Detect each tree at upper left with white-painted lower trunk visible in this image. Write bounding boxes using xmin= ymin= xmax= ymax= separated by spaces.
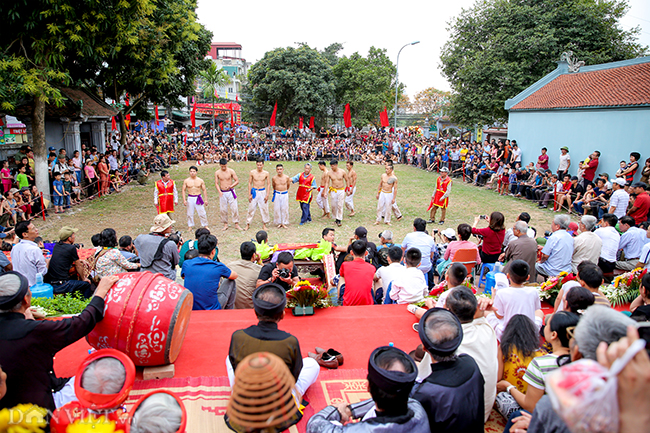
xmin=0 ymin=0 xmax=152 ymax=191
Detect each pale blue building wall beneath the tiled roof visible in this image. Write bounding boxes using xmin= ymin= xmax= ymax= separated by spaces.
xmin=508 ymin=107 xmax=650 ymax=180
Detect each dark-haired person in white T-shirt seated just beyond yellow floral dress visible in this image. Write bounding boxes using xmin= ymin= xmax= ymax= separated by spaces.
xmin=479 ymin=260 xmax=542 ymax=339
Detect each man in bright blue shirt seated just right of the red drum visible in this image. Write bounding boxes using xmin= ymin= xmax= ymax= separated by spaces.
xmin=181 ymin=235 xmax=237 ymax=310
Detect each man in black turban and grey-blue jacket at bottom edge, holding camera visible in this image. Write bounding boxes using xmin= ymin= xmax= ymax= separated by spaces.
xmin=307 ymin=346 xmax=431 ymax=433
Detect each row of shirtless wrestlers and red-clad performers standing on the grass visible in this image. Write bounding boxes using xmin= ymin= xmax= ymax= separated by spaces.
xmin=154 ymin=159 xmax=452 ymax=231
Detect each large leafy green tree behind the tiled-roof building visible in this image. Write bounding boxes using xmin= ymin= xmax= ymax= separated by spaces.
xmin=441 ymin=0 xmax=646 ymax=125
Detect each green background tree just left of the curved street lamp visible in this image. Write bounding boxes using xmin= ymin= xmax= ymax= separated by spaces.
xmin=333 ymin=47 xmax=403 ymax=127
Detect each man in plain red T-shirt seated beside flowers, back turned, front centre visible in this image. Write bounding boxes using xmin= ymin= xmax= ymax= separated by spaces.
xmin=339 ymin=240 xmax=376 ymax=306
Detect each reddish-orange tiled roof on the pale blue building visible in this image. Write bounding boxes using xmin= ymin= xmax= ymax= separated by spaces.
xmin=511 ymin=62 xmax=650 ymax=110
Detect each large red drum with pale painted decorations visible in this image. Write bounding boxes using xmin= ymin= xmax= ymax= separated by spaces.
xmin=86 ymin=272 xmax=194 ymax=367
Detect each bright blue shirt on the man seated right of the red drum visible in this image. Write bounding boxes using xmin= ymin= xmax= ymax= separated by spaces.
xmin=181 ymin=257 xmax=231 ymax=310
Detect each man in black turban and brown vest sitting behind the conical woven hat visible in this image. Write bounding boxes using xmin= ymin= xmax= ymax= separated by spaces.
xmin=226 ymin=283 xmax=320 ymax=396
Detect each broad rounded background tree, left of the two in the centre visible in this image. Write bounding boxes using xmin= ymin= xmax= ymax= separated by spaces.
xmin=244 ymin=44 xmax=334 ymax=125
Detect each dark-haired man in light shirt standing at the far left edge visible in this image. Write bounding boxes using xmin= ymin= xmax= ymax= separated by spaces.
xmin=11 ymin=221 xmax=47 ymax=287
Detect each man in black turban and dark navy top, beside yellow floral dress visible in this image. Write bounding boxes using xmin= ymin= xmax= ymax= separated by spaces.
xmin=411 ymin=308 xmax=484 ymax=433
